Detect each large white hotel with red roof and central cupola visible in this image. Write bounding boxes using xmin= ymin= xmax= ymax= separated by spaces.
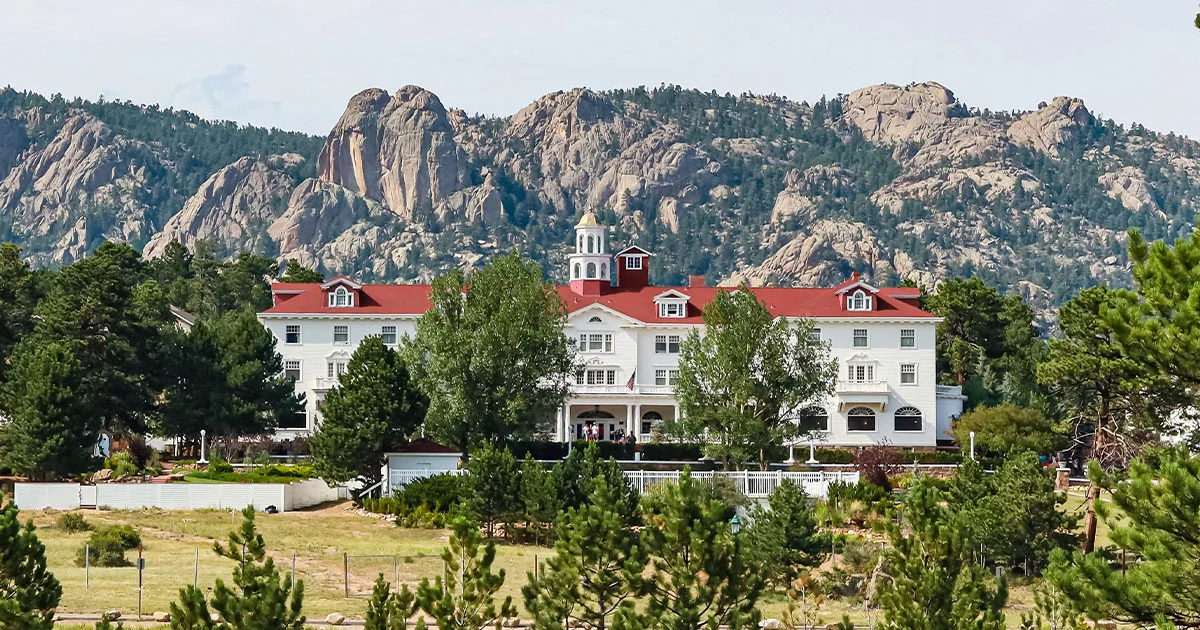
xmin=259 ymin=212 xmax=964 ymax=449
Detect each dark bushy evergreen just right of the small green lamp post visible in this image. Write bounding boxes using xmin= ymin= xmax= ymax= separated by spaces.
xmin=742 ymin=481 xmax=829 ymax=584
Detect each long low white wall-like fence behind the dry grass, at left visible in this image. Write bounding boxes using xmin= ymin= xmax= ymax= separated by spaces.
xmin=14 ymin=479 xmax=340 ymax=511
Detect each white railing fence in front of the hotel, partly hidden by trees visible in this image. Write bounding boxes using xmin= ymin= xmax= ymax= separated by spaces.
xmin=390 ymin=470 xmax=858 ymax=498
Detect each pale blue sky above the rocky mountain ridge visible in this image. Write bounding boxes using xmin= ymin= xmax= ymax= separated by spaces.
xmin=0 ymin=0 xmax=1200 ymax=137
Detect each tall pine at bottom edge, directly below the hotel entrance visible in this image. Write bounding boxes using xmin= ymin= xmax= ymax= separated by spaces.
xmin=521 ymin=478 xmax=647 ymax=630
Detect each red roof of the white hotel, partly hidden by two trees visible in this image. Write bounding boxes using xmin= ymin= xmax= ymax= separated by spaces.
xmin=264 ymin=283 xmax=935 ymax=324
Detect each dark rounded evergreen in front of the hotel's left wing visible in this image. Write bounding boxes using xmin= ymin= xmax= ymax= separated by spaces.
xmin=308 ymin=337 xmax=427 ymax=487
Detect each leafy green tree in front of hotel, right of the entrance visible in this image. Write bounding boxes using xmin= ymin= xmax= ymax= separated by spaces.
xmin=666 ymin=289 xmax=836 ymax=469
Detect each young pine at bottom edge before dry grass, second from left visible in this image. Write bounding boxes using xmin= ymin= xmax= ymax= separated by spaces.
xmin=170 ymin=508 xmax=305 ymax=630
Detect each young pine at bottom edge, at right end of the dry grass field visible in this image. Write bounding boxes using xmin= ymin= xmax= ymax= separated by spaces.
xmin=416 ymin=516 xmax=516 ymax=630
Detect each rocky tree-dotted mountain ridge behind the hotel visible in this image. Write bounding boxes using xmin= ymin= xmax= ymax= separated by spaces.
xmin=0 ymin=82 xmax=1200 ymax=319
